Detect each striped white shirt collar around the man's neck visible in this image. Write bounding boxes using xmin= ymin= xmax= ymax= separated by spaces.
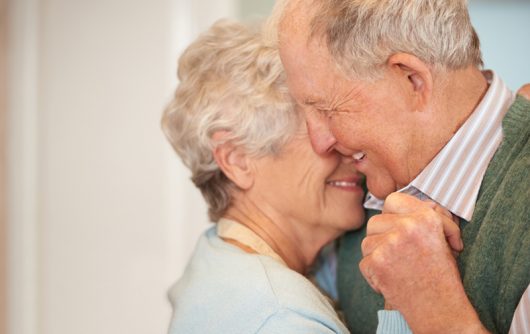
xmin=364 ymin=71 xmax=515 ymax=221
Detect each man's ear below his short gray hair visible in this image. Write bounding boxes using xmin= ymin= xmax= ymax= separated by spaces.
xmin=387 ymin=53 xmax=433 ymax=111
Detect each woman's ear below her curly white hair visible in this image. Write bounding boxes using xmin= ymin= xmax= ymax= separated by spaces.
xmin=212 ymin=131 xmax=254 ymax=190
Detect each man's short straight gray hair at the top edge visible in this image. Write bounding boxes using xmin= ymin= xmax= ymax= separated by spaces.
xmin=302 ymin=0 xmax=482 ymax=78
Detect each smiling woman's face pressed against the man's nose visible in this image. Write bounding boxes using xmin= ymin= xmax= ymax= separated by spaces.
xmin=254 ymin=124 xmax=364 ymax=236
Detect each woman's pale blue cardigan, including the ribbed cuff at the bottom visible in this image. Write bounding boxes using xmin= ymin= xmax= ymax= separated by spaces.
xmin=169 ymin=227 xmax=408 ymax=334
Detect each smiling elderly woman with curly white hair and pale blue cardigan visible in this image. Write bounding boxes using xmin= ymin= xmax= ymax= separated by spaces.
xmin=163 ymin=21 xmax=412 ymax=333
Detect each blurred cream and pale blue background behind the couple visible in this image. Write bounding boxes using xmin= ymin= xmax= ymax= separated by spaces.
xmin=0 ymin=0 xmax=530 ymax=334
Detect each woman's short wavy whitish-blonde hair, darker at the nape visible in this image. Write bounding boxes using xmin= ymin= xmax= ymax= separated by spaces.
xmin=162 ymin=20 xmax=300 ymax=221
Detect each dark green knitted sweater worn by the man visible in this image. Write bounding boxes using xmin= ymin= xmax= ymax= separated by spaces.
xmin=337 ymin=96 xmax=530 ymax=334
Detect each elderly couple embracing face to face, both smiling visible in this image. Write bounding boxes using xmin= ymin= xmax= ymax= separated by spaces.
xmin=162 ymin=0 xmax=530 ymax=333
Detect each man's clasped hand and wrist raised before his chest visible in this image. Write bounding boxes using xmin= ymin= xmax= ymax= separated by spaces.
xmin=359 ymin=193 xmax=485 ymax=333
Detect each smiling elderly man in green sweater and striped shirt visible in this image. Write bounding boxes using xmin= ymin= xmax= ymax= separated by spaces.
xmin=276 ymin=0 xmax=530 ymax=333
